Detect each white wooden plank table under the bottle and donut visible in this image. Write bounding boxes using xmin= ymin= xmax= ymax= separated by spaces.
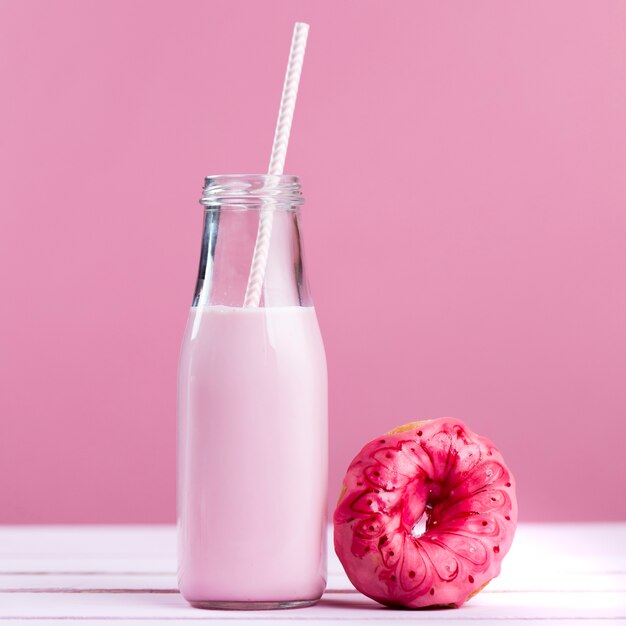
xmin=0 ymin=523 xmax=626 ymax=626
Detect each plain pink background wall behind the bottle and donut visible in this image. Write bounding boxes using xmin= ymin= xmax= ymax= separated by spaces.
xmin=0 ymin=0 xmax=626 ymax=522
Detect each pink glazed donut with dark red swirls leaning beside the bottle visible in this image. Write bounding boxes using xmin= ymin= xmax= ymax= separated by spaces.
xmin=334 ymin=418 xmax=517 ymax=608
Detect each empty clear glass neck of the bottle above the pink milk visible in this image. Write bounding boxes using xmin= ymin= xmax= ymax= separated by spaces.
xmin=193 ymin=175 xmax=312 ymax=307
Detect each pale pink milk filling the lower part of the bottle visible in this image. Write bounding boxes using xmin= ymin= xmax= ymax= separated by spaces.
xmin=178 ymin=305 xmax=328 ymax=608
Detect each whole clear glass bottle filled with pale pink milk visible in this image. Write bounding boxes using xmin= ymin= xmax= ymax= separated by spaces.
xmin=178 ymin=175 xmax=328 ymax=609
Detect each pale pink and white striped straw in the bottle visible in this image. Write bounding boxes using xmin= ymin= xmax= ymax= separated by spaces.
xmin=243 ymin=22 xmax=309 ymax=307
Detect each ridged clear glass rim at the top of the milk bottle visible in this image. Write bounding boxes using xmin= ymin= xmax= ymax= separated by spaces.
xmin=200 ymin=174 xmax=304 ymax=208
